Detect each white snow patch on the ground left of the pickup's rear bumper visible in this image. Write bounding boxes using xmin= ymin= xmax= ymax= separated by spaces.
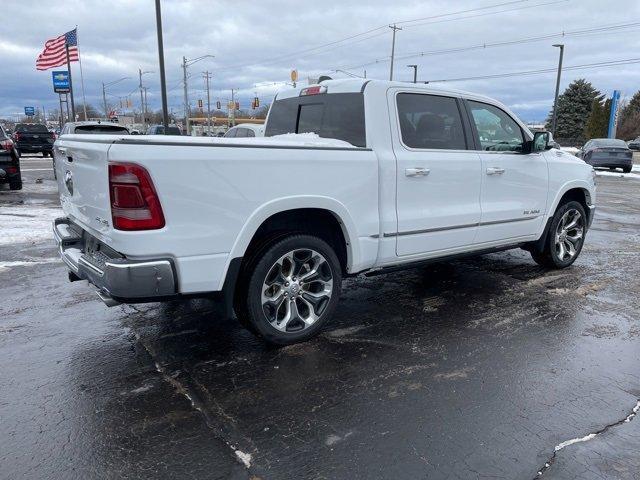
xmin=0 ymin=205 xmax=63 ymax=245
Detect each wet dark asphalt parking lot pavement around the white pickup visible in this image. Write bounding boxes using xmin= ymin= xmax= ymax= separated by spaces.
xmin=0 ymin=160 xmax=640 ymax=479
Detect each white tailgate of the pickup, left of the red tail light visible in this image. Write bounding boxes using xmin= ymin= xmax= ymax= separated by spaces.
xmin=53 ymin=135 xmax=113 ymax=237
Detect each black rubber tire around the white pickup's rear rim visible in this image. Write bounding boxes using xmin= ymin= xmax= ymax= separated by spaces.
xmin=236 ymin=234 xmax=342 ymax=345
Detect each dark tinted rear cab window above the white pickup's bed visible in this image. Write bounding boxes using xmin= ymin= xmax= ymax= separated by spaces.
xmin=264 ymin=93 xmax=367 ymax=147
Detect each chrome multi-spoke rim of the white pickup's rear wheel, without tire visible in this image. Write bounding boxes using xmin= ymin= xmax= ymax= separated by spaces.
xmin=262 ymin=248 xmax=333 ymax=332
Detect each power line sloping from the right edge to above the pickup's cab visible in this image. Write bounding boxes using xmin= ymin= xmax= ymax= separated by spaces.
xmin=340 ymin=22 xmax=640 ymax=70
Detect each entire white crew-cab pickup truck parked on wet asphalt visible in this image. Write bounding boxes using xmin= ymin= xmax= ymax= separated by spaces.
xmin=54 ymin=79 xmax=595 ymax=344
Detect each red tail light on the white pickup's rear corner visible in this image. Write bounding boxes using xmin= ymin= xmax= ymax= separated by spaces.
xmin=109 ymin=163 xmax=164 ymax=230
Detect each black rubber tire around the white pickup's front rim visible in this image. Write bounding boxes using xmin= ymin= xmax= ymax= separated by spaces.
xmin=531 ymin=200 xmax=588 ymax=269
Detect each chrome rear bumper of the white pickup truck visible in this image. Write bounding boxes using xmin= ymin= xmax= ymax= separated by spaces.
xmin=53 ymin=217 xmax=177 ymax=306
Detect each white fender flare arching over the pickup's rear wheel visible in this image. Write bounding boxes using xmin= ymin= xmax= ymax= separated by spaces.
xmin=220 ymin=195 xmax=361 ymax=288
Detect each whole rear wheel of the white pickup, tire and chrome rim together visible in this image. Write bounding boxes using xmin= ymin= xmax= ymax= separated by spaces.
xmin=238 ymin=235 xmax=342 ymax=345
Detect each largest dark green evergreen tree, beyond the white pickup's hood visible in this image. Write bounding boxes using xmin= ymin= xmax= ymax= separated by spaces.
xmin=546 ymin=78 xmax=600 ymax=142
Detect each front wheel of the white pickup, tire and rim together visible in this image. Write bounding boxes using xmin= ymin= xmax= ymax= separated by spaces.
xmin=531 ymin=201 xmax=587 ymax=268
